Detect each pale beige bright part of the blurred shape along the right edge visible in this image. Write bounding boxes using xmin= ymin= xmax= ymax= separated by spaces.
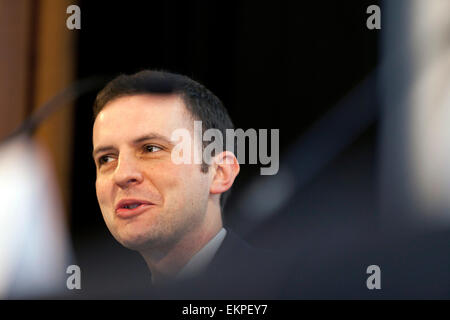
xmin=409 ymin=0 xmax=450 ymax=222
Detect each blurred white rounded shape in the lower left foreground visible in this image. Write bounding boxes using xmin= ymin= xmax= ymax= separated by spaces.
xmin=0 ymin=136 xmax=71 ymax=298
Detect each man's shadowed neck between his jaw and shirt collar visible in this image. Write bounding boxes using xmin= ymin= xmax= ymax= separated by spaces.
xmin=140 ymin=201 xmax=222 ymax=284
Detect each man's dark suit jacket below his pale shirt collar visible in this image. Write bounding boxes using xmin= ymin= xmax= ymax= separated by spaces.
xmin=154 ymin=229 xmax=284 ymax=299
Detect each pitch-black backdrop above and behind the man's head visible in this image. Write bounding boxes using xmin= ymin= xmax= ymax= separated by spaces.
xmin=71 ymin=1 xmax=378 ymax=235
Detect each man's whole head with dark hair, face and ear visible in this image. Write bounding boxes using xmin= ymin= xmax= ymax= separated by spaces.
xmin=93 ymin=71 xmax=239 ymax=250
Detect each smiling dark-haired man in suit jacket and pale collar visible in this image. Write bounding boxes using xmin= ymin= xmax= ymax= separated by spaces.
xmin=93 ymin=71 xmax=274 ymax=296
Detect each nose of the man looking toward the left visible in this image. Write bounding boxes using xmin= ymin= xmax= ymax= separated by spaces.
xmin=114 ymin=155 xmax=143 ymax=189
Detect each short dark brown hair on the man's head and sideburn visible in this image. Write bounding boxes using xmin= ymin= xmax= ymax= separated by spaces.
xmin=94 ymin=70 xmax=236 ymax=212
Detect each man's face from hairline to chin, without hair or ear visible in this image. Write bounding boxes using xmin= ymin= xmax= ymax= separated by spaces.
xmin=93 ymin=95 xmax=211 ymax=250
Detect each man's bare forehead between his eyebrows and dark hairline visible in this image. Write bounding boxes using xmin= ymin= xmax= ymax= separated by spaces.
xmin=93 ymin=94 xmax=193 ymax=145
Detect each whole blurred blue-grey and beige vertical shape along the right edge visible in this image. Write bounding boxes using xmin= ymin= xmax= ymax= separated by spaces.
xmin=380 ymin=0 xmax=450 ymax=227
